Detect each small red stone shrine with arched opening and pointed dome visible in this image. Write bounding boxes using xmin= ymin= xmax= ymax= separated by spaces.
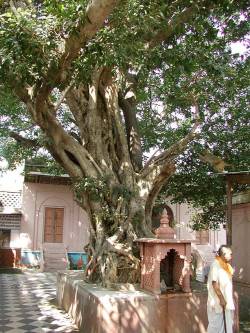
xmin=136 ymin=209 xmax=191 ymax=294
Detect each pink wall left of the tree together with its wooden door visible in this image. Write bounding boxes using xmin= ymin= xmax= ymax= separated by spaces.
xmin=20 ymin=175 xmax=88 ymax=251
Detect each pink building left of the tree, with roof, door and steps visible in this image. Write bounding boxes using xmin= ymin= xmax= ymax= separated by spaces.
xmin=0 ymin=163 xmax=89 ymax=270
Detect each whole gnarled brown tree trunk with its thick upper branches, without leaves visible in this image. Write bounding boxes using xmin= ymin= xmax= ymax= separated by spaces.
xmin=3 ymin=0 xmax=205 ymax=285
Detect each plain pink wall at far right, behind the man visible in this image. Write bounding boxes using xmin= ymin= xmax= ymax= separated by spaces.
xmin=232 ymin=203 xmax=250 ymax=285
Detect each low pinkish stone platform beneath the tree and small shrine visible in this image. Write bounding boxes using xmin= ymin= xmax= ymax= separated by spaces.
xmin=57 ymin=271 xmax=211 ymax=333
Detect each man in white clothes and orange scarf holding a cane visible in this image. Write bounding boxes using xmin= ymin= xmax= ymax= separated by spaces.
xmin=207 ymin=245 xmax=234 ymax=333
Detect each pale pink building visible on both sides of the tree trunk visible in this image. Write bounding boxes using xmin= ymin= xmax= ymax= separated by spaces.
xmin=0 ymin=161 xmax=225 ymax=272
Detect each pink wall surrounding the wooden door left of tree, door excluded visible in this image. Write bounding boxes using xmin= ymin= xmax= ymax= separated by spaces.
xmin=20 ymin=182 xmax=89 ymax=251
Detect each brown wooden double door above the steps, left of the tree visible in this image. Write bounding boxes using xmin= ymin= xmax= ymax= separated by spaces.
xmin=44 ymin=207 xmax=64 ymax=243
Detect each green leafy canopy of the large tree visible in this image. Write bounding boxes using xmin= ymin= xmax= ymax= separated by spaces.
xmin=0 ymin=0 xmax=250 ymax=229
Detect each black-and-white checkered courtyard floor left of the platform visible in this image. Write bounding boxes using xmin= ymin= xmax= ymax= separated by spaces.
xmin=0 ymin=272 xmax=78 ymax=333
